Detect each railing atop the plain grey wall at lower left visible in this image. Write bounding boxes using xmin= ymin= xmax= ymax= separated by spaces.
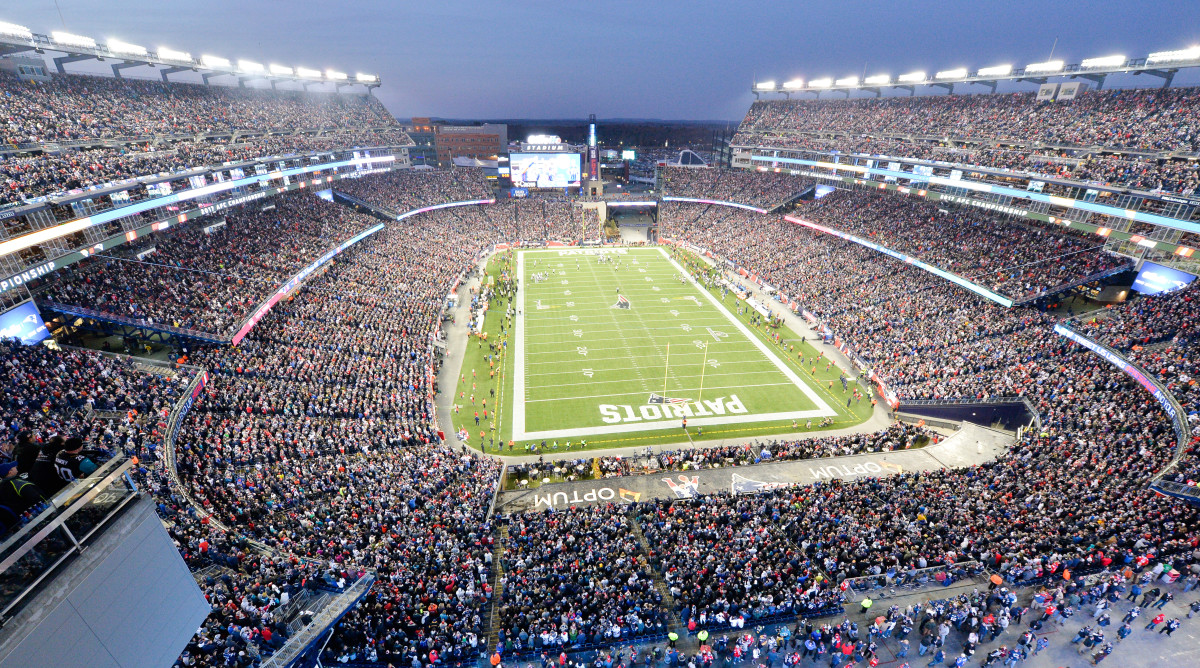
xmin=0 ymin=456 xmax=138 ymax=620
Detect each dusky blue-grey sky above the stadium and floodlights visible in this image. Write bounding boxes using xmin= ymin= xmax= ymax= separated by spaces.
xmin=9 ymin=0 xmax=1200 ymax=120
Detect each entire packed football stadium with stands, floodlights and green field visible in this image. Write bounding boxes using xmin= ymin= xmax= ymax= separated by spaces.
xmin=0 ymin=7 xmax=1200 ymax=668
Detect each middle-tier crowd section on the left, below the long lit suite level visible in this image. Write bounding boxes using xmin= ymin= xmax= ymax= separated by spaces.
xmin=38 ymin=194 xmax=378 ymax=337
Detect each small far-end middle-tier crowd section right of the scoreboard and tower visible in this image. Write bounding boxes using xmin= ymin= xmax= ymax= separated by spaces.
xmin=662 ymin=167 xmax=812 ymax=209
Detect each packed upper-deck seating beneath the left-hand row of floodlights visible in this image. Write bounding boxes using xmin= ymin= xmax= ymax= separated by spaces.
xmin=0 ymin=72 xmax=412 ymax=206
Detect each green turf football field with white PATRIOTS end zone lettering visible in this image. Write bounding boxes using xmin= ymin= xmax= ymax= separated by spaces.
xmin=456 ymin=248 xmax=870 ymax=453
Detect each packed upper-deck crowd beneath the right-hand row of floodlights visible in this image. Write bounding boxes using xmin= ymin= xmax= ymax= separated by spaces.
xmin=733 ymin=88 xmax=1200 ymax=194
